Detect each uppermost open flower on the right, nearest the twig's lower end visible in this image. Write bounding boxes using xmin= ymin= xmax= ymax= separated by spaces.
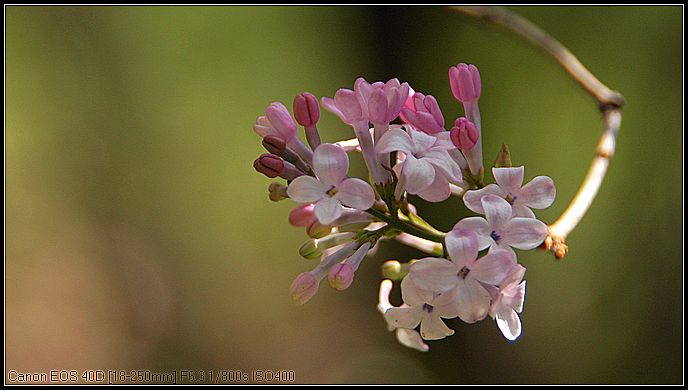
xmin=463 ymin=166 xmax=556 ymax=218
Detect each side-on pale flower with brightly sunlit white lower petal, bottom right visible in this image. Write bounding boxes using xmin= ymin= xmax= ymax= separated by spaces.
xmin=490 ymin=265 xmax=526 ymax=341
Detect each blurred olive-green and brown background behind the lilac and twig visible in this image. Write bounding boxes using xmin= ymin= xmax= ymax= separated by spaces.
xmin=5 ymin=6 xmax=683 ymax=383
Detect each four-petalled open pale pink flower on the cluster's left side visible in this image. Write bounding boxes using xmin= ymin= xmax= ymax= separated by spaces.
xmin=287 ymin=144 xmax=375 ymax=225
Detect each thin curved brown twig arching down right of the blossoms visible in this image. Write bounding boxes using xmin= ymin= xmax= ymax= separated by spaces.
xmin=450 ymin=6 xmax=624 ymax=259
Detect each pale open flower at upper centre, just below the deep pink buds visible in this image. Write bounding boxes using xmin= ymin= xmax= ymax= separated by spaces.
xmin=375 ymin=126 xmax=462 ymax=202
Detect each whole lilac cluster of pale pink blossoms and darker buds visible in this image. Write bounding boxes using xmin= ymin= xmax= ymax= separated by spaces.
xmin=253 ymin=64 xmax=556 ymax=351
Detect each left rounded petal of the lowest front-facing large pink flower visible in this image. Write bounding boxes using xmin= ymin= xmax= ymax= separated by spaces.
xmin=412 ymin=257 xmax=459 ymax=292
